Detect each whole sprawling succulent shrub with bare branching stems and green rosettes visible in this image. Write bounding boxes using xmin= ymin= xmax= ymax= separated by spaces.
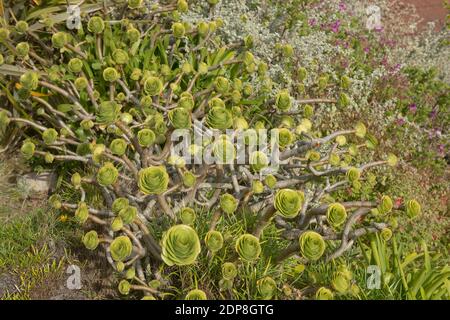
xmin=0 ymin=0 xmax=420 ymax=299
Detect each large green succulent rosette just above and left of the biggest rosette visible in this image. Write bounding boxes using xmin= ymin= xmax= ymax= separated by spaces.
xmin=138 ymin=166 xmax=170 ymax=194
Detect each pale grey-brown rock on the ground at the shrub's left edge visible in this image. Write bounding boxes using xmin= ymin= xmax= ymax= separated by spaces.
xmin=17 ymin=171 xmax=57 ymax=197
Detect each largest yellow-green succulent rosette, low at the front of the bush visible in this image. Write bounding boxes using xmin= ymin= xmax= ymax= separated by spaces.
xmin=161 ymin=224 xmax=201 ymax=266
